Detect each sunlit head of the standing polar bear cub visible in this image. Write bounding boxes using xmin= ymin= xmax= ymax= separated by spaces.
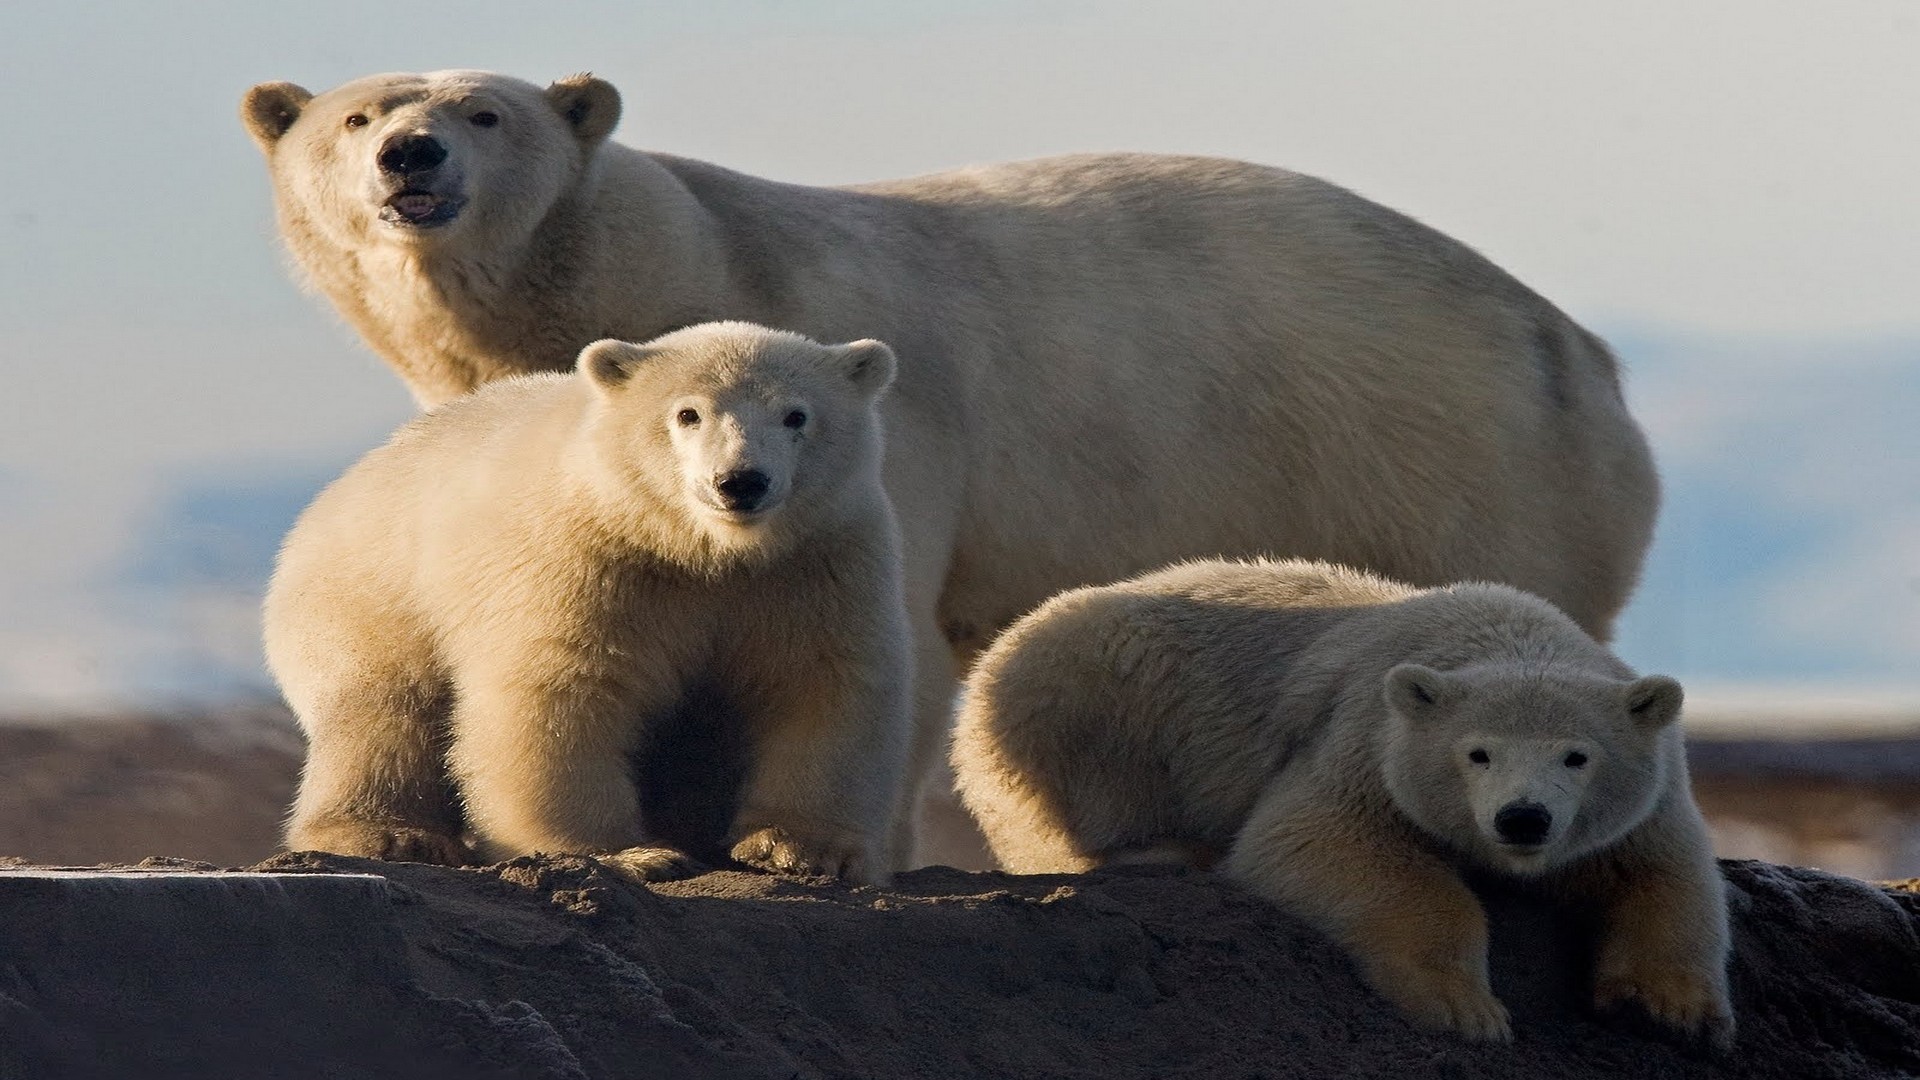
xmin=578 ymin=323 xmax=895 ymax=553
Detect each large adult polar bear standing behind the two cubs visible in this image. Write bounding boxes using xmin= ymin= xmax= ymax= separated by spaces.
xmin=242 ymin=71 xmax=1659 ymax=861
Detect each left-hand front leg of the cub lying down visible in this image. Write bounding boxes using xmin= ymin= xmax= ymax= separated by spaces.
xmin=1221 ymin=778 xmax=1513 ymax=1042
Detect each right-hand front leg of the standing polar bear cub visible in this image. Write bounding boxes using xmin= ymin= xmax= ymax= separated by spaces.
xmin=730 ymin=557 xmax=912 ymax=884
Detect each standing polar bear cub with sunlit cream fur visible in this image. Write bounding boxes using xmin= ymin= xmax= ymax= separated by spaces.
xmin=265 ymin=323 xmax=910 ymax=880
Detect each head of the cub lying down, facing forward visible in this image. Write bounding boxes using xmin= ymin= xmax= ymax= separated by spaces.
xmin=1384 ymin=661 xmax=1684 ymax=876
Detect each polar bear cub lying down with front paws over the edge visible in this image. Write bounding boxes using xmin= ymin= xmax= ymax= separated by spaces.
xmin=952 ymin=561 xmax=1732 ymax=1040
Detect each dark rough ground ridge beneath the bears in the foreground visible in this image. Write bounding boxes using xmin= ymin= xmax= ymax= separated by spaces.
xmin=0 ymin=853 xmax=1920 ymax=1080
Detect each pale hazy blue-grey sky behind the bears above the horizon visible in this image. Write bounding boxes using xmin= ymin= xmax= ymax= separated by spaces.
xmin=0 ymin=0 xmax=1920 ymax=707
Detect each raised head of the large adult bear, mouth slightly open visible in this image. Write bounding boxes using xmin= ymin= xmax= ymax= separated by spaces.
xmin=240 ymin=71 xmax=620 ymax=248
